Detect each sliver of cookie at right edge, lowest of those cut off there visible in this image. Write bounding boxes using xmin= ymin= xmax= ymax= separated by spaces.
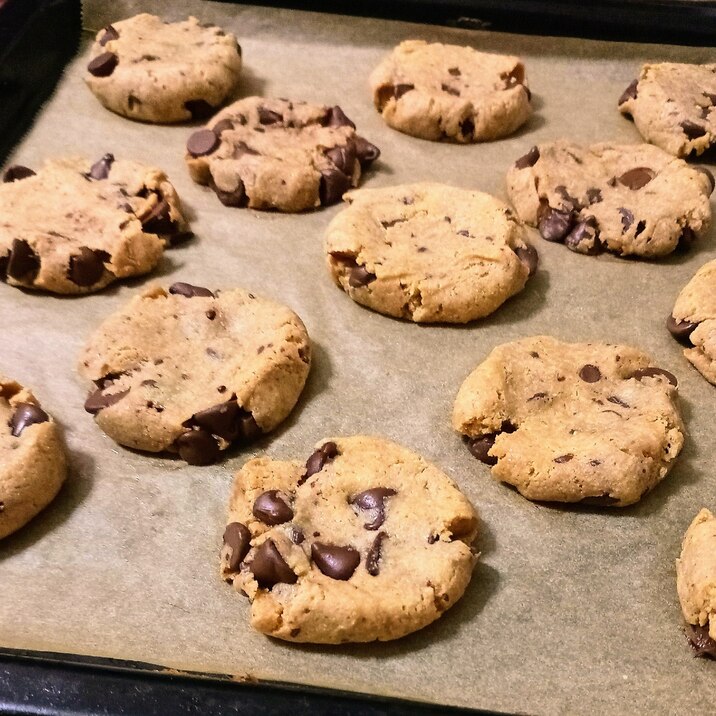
xmin=676 ymin=508 xmax=716 ymax=658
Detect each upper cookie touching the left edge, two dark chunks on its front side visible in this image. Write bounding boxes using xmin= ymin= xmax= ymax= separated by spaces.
xmin=0 ymin=154 xmax=189 ymax=294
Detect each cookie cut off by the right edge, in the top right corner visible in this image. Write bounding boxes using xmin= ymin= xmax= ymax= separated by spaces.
xmin=619 ymin=62 xmax=716 ymax=157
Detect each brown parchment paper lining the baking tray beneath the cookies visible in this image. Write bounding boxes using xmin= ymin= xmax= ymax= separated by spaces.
xmin=0 ymin=0 xmax=716 ymax=714
